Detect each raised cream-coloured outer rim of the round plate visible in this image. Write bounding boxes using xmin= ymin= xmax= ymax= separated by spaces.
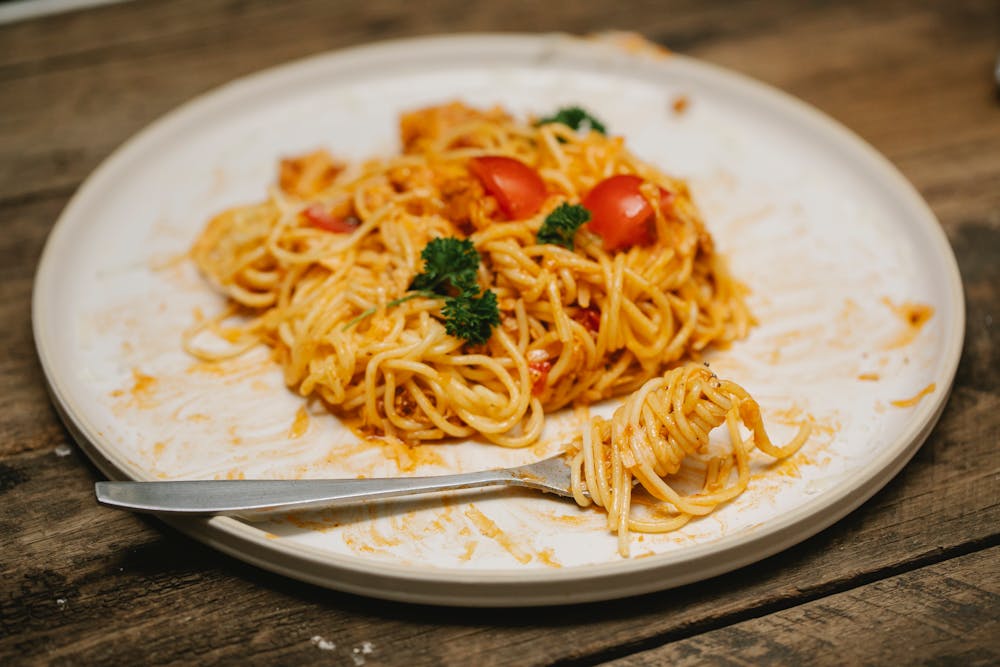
xmin=31 ymin=33 xmax=965 ymax=607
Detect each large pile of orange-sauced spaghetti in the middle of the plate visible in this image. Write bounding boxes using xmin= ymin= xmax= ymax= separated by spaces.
xmin=187 ymin=103 xmax=751 ymax=447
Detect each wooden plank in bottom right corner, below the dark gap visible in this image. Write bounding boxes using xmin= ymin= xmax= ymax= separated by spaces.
xmin=606 ymin=548 xmax=1000 ymax=667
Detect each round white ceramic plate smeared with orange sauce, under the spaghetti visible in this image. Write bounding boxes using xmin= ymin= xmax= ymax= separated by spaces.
xmin=33 ymin=35 xmax=965 ymax=606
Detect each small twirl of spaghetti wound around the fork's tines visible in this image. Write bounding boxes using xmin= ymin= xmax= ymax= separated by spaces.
xmin=572 ymin=363 xmax=810 ymax=556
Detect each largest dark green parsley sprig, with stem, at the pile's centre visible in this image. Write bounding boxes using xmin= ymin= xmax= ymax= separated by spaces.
xmin=344 ymin=238 xmax=500 ymax=345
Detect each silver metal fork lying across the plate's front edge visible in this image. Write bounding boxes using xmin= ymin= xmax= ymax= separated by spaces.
xmin=94 ymin=453 xmax=573 ymax=515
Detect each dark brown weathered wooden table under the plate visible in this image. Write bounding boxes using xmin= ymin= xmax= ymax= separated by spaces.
xmin=0 ymin=0 xmax=1000 ymax=666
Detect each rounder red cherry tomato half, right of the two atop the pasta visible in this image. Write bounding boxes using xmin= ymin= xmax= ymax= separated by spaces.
xmin=583 ymin=174 xmax=669 ymax=250
